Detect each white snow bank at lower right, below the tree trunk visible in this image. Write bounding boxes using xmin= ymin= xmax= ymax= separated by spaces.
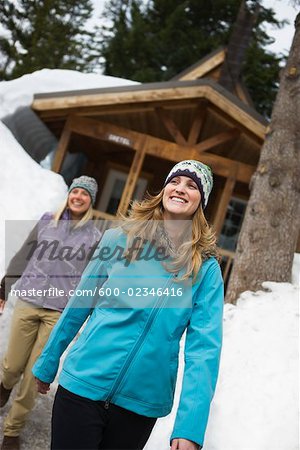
xmin=145 ymin=282 xmax=299 ymax=450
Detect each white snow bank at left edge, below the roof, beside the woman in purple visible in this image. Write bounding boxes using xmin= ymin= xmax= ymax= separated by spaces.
xmin=0 ymin=119 xmax=67 ymax=276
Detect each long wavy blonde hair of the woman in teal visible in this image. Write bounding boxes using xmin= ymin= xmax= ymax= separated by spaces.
xmin=121 ymin=189 xmax=218 ymax=281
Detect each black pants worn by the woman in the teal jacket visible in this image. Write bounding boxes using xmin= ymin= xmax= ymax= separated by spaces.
xmin=51 ymin=386 xmax=157 ymax=450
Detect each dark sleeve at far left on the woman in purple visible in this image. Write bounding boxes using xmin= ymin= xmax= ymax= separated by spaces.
xmin=0 ymin=224 xmax=39 ymax=301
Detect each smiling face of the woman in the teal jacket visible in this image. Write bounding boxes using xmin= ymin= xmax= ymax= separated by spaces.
xmin=162 ymin=175 xmax=201 ymax=220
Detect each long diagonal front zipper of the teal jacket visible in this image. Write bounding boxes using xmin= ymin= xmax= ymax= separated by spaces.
xmin=104 ymin=275 xmax=177 ymax=409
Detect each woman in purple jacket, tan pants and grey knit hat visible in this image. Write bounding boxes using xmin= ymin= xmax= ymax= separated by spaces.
xmin=0 ymin=176 xmax=101 ymax=450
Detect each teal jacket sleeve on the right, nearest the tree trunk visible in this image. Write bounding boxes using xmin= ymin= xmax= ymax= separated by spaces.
xmin=171 ymin=260 xmax=224 ymax=445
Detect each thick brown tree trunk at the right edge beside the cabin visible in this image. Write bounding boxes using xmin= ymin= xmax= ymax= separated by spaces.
xmin=226 ymin=14 xmax=300 ymax=302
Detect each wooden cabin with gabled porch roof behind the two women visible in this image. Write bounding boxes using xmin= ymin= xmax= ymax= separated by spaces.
xmin=32 ymin=49 xmax=267 ymax=278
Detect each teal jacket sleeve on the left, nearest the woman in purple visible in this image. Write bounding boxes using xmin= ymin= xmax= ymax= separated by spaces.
xmin=32 ymin=232 xmax=113 ymax=383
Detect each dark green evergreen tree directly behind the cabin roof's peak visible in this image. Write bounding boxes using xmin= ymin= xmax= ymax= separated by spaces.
xmin=101 ymin=0 xmax=284 ymax=115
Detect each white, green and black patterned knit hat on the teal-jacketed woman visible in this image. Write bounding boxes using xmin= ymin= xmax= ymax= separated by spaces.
xmin=164 ymin=159 xmax=213 ymax=209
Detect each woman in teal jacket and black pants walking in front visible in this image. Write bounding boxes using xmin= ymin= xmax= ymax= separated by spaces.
xmin=33 ymin=160 xmax=223 ymax=450
